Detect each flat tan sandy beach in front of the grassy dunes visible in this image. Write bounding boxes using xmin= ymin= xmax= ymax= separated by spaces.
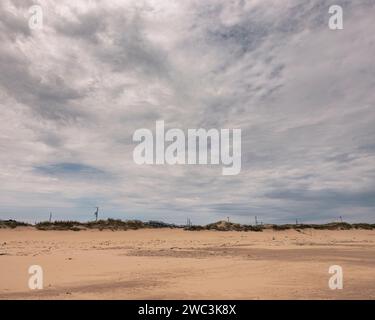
xmin=0 ymin=228 xmax=375 ymax=299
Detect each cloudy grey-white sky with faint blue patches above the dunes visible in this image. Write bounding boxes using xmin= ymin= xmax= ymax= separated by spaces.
xmin=0 ymin=0 xmax=375 ymax=223
